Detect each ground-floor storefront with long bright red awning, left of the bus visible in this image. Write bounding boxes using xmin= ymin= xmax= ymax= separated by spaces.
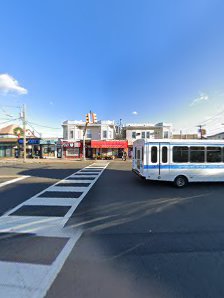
xmin=91 ymin=140 xmax=128 ymax=159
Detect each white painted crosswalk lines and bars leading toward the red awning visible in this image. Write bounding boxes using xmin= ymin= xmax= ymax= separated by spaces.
xmin=0 ymin=163 xmax=109 ymax=298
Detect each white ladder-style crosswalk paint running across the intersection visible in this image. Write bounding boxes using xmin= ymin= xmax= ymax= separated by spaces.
xmin=0 ymin=163 xmax=109 ymax=298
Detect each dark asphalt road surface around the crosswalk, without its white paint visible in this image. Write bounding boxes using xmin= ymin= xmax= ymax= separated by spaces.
xmin=0 ymin=161 xmax=224 ymax=298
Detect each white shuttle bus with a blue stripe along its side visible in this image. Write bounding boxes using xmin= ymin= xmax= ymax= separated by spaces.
xmin=132 ymin=139 xmax=224 ymax=187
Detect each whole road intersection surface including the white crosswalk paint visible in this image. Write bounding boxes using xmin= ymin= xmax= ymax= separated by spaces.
xmin=0 ymin=161 xmax=224 ymax=298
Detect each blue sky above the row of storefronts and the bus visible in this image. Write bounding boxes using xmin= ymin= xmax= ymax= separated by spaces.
xmin=0 ymin=0 xmax=224 ymax=133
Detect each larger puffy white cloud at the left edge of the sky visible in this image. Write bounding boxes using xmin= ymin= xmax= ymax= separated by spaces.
xmin=0 ymin=73 xmax=28 ymax=95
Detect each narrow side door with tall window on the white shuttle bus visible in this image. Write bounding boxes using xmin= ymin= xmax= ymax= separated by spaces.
xmin=159 ymin=143 xmax=170 ymax=178
